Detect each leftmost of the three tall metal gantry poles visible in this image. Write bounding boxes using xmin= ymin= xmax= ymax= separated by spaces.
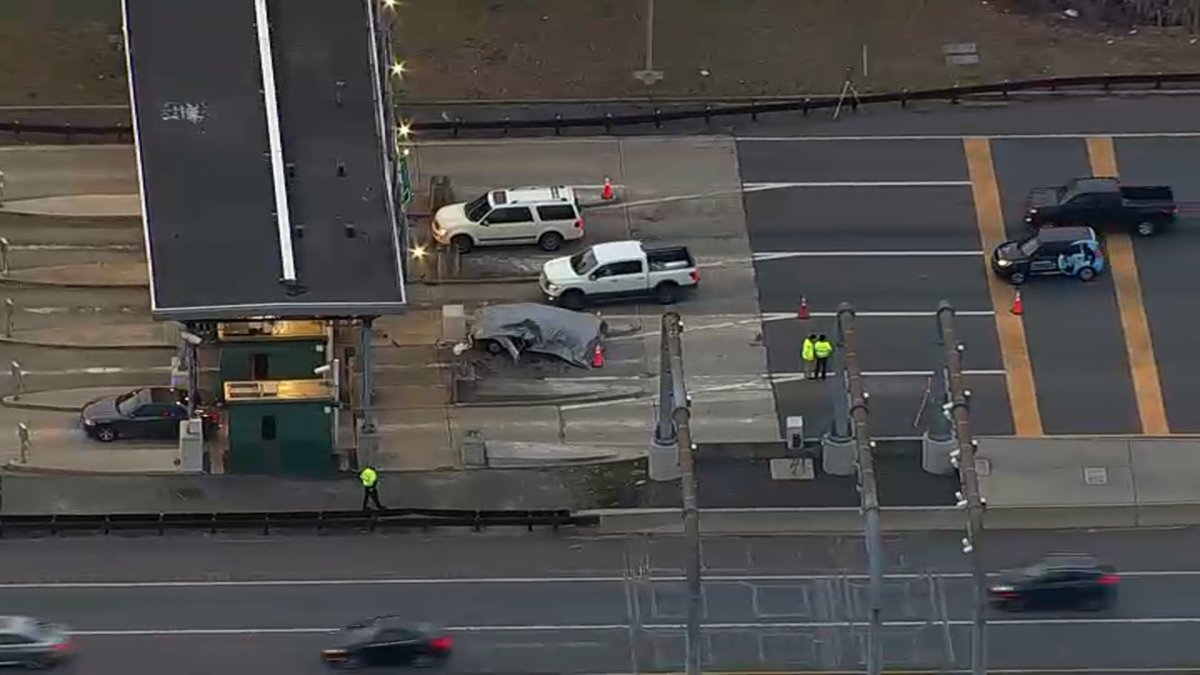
xmin=664 ymin=312 xmax=704 ymax=675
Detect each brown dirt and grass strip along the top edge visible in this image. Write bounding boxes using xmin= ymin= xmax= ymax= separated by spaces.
xmin=0 ymin=0 xmax=1200 ymax=106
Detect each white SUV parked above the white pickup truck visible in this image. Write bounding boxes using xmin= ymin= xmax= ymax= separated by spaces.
xmin=433 ymin=185 xmax=583 ymax=253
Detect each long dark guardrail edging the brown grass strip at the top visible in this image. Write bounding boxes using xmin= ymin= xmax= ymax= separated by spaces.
xmin=7 ymin=72 xmax=1200 ymax=142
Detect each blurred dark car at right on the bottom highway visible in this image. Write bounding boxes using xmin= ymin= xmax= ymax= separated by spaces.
xmin=988 ymin=555 xmax=1120 ymax=611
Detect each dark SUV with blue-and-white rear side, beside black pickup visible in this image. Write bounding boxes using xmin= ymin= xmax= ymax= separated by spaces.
xmin=991 ymin=227 xmax=1104 ymax=286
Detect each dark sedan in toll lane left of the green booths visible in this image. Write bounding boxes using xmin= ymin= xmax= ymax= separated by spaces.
xmin=79 ymin=387 xmax=217 ymax=443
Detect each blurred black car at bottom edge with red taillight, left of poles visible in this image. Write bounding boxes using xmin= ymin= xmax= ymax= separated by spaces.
xmin=320 ymin=616 xmax=454 ymax=669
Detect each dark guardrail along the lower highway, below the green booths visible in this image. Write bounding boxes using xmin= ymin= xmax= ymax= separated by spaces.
xmin=0 ymin=508 xmax=600 ymax=538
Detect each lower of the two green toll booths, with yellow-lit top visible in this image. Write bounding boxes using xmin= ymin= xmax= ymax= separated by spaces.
xmin=224 ymin=380 xmax=338 ymax=477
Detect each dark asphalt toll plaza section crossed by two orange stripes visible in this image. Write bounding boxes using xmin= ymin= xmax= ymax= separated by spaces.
xmin=738 ymin=120 xmax=1200 ymax=438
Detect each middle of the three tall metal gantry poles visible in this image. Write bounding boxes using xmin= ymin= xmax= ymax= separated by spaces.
xmin=838 ymin=303 xmax=883 ymax=675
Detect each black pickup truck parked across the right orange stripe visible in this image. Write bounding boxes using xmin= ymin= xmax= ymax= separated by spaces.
xmin=1025 ymin=178 xmax=1180 ymax=237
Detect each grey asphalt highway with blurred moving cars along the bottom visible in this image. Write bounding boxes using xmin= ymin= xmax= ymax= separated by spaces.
xmin=7 ymin=530 xmax=1200 ymax=675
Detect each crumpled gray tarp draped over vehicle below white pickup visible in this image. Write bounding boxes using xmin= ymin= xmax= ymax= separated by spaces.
xmin=470 ymin=303 xmax=601 ymax=368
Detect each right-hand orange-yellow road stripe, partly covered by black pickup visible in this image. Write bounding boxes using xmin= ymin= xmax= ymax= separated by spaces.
xmin=1087 ymin=136 xmax=1171 ymax=436
